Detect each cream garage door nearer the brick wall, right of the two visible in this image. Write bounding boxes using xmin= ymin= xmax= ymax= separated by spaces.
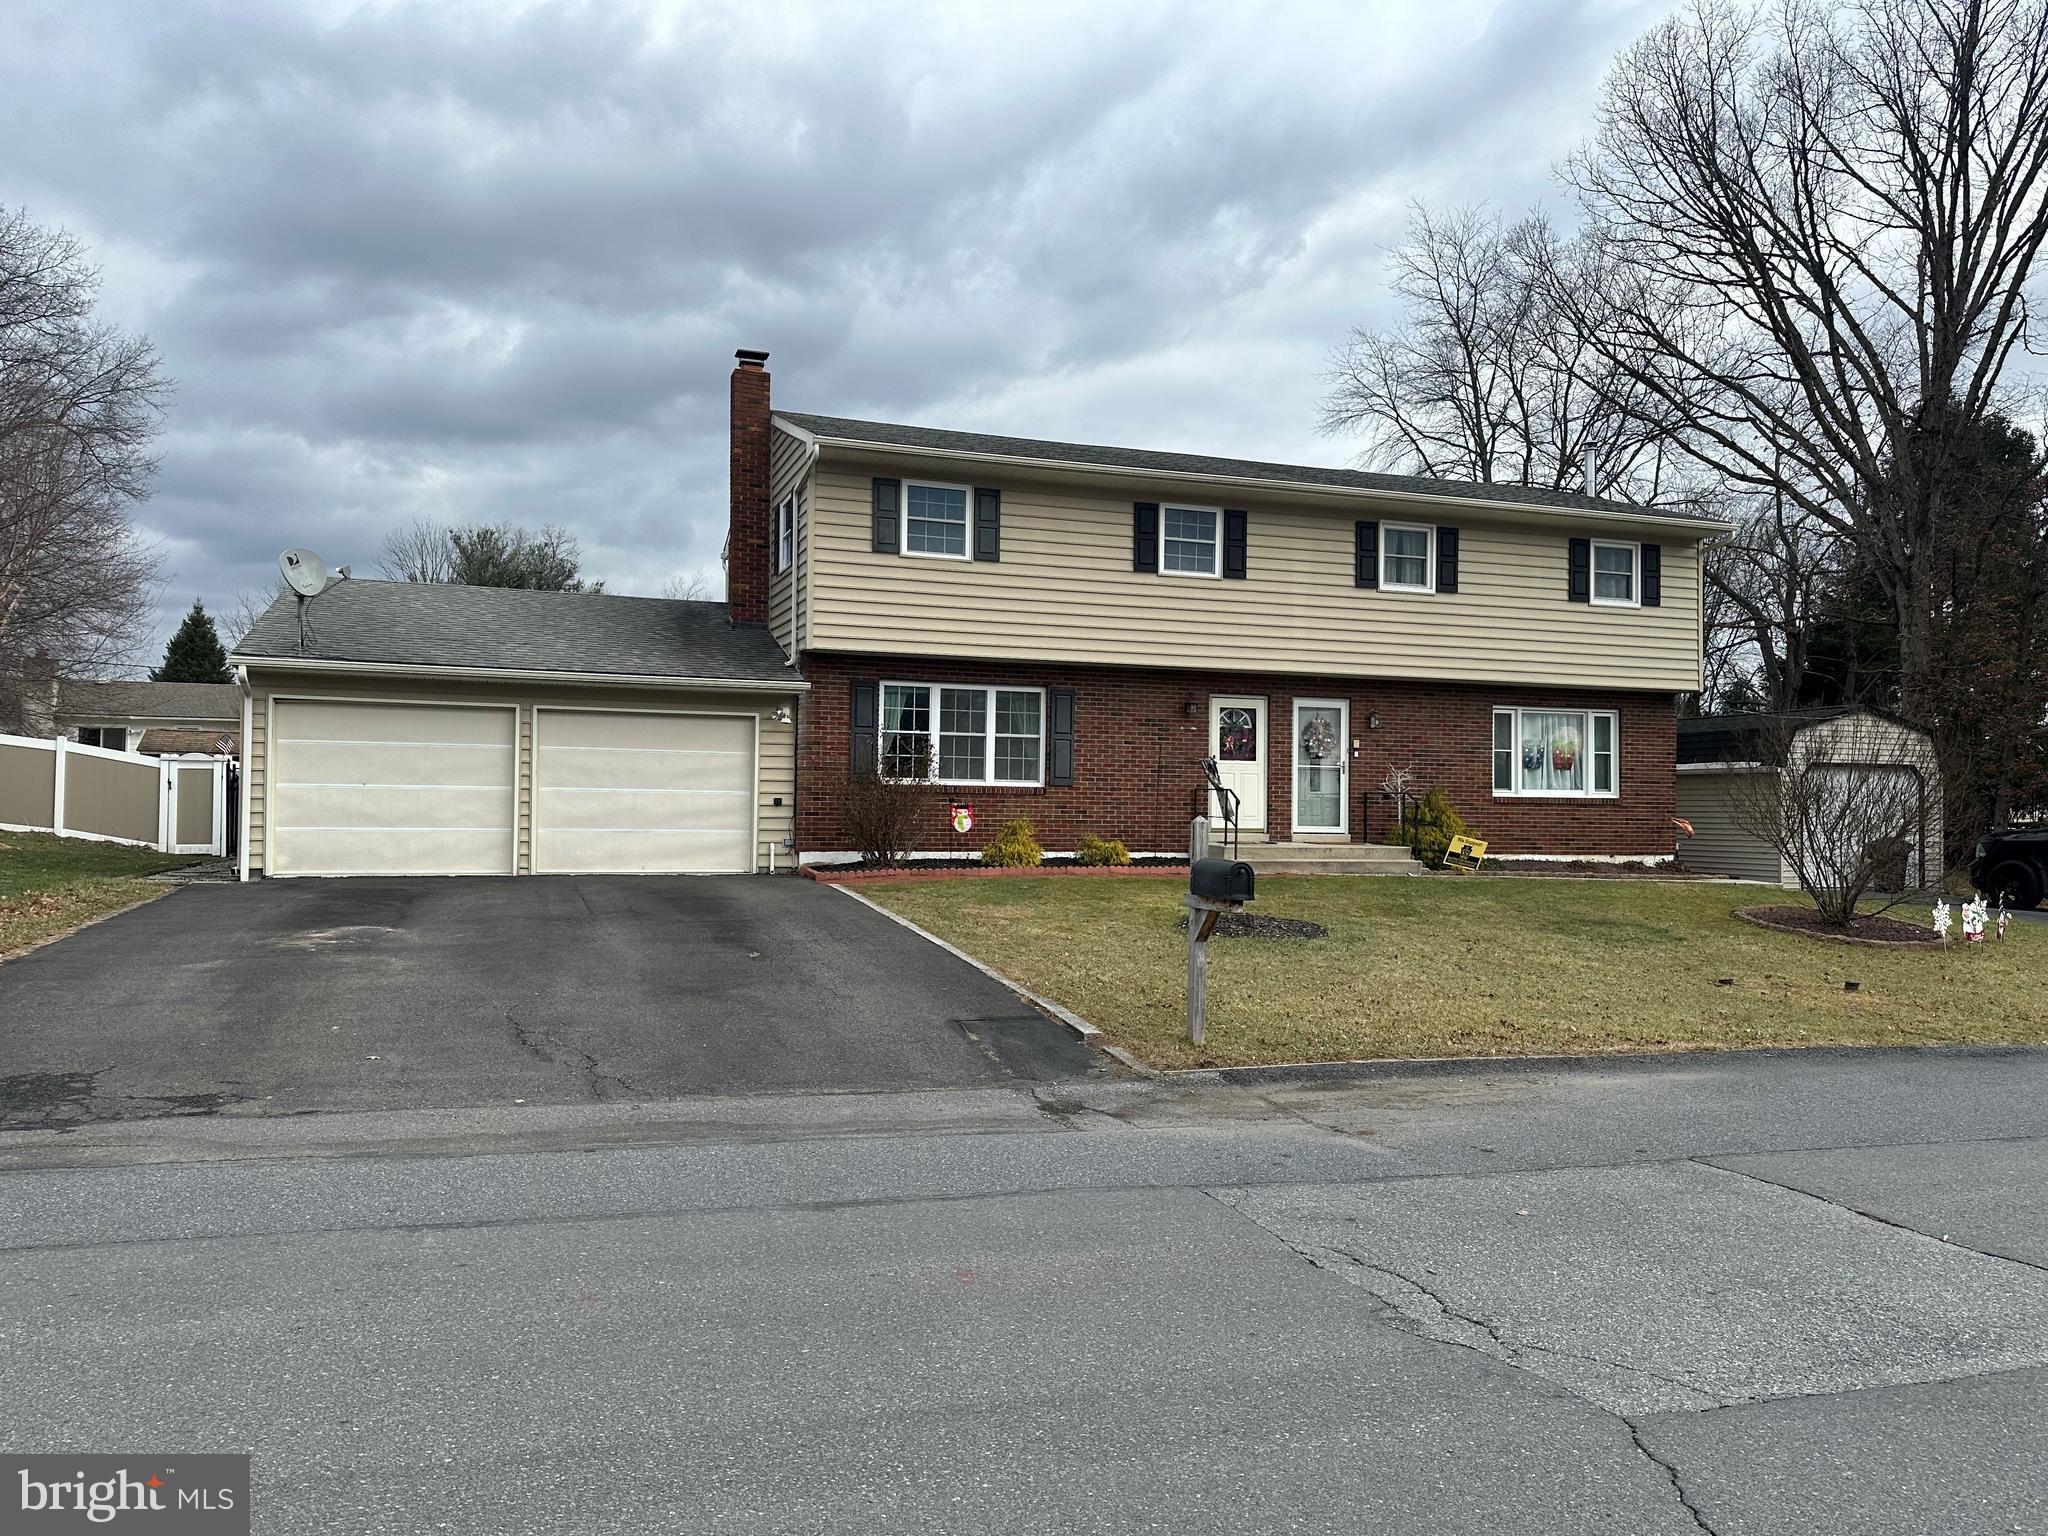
xmin=532 ymin=709 xmax=756 ymax=874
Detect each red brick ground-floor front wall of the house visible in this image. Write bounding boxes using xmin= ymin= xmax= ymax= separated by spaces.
xmin=797 ymin=651 xmax=1677 ymax=856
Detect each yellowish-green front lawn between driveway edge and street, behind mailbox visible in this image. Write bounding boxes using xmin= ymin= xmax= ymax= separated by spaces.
xmin=866 ymin=877 xmax=2048 ymax=1067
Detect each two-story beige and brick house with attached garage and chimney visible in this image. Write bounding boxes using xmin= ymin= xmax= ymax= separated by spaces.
xmin=233 ymin=350 xmax=1724 ymax=874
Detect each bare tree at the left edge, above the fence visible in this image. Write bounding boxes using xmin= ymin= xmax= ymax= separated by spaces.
xmin=0 ymin=209 xmax=168 ymax=704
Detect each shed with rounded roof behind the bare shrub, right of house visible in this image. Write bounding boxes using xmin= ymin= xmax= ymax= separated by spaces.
xmin=1677 ymin=707 xmax=1942 ymax=889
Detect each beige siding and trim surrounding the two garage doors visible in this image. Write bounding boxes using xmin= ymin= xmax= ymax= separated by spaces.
xmin=244 ymin=666 xmax=797 ymax=874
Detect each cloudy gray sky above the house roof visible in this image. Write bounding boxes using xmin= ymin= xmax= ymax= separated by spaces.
xmin=0 ymin=0 xmax=1667 ymax=659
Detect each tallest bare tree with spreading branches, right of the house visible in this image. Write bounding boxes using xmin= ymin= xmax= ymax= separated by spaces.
xmin=1544 ymin=0 xmax=2048 ymax=713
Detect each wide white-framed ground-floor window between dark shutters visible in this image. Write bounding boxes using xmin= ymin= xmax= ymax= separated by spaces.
xmin=877 ymin=682 xmax=1044 ymax=786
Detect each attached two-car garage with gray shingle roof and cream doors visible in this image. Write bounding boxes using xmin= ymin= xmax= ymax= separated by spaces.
xmin=231 ymin=580 xmax=807 ymax=877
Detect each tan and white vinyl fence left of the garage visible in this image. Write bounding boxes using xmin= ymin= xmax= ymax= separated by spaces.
xmin=0 ymin=735 xmax=227 ymax=854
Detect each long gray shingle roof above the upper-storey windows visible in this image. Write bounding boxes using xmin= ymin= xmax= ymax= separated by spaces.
xmin=776 ymin=410 xmax=1722 ymax=528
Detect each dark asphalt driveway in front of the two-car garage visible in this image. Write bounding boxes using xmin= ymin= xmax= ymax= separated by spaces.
xmin=0 ymin=877 xmax=1096 ymax=1128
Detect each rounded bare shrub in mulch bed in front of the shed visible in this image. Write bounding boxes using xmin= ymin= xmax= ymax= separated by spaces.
xmin=1729 ymin=715 xmax=1942 ymax=928
